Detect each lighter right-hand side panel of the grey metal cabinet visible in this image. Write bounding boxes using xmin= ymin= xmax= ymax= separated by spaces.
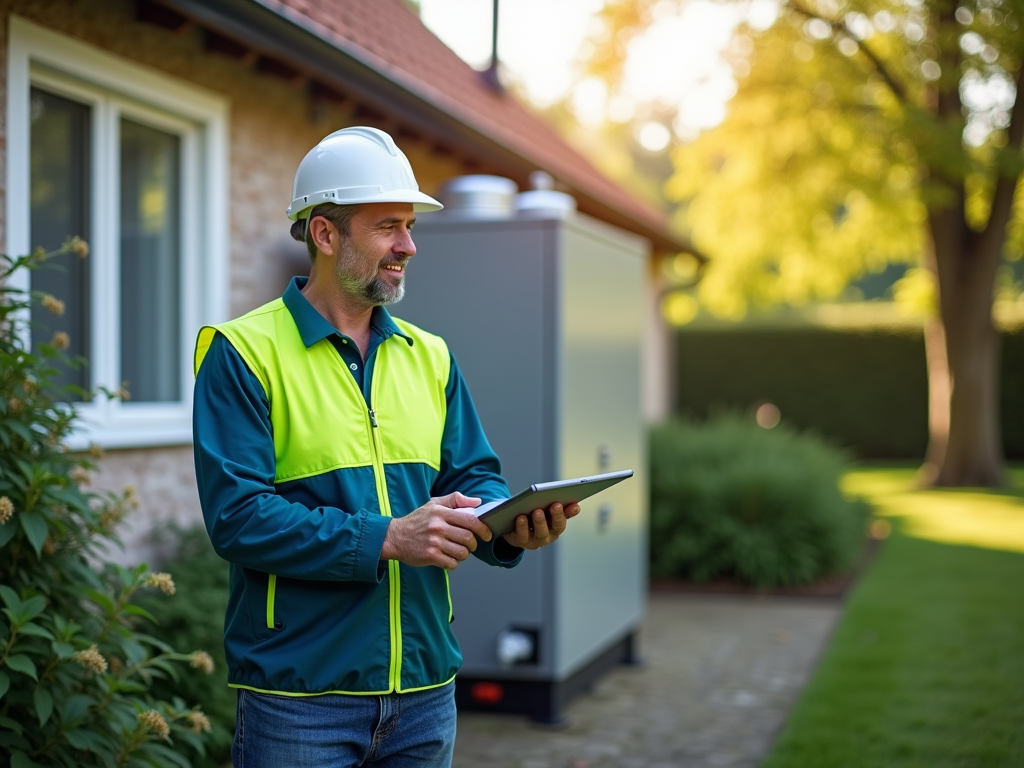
xmin=553 ymin=219 xmax=646 ymax=679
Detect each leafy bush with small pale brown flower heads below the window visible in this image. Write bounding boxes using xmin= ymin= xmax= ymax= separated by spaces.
xmin=0 ymin=246 xmax=213 ymax=768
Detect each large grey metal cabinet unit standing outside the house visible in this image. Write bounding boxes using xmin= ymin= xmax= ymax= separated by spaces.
xmin=393 ymin=202 xmax=649 ymax=722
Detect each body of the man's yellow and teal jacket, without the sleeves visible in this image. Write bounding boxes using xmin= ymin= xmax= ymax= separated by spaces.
xmin=195 ymin=299 xmax=462 ymax=696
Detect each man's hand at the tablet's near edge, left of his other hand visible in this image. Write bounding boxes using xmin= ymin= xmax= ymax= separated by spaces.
xmin=381 ymin=493 xmax=495 ymax=570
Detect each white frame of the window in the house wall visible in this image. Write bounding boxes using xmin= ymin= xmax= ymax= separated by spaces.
xmin=6 ymin=16 xmax=228 ymax=449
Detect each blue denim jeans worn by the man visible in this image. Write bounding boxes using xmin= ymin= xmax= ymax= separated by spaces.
xmin=231 ymin=683 xmax=456 ymax=768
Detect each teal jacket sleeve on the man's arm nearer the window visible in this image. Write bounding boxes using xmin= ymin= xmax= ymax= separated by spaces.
xmin=193 ymin=333 xmax=389 ymax=582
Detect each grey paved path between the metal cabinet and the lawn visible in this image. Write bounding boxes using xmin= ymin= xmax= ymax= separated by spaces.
xmin=453 ymin=593 xmax=842 ymax=768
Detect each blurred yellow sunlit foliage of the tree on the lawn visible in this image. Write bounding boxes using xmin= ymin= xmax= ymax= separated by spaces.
xmin=669 ymin=0 xmax=1024 ymax=315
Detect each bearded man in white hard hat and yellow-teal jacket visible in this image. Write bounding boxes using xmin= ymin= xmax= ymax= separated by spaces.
xmin=194 ymin=128 xmax=579 ymax=768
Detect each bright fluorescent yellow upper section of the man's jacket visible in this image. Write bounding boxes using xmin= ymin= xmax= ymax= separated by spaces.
xmin=195 ymin=299 xmax=451 ymax=483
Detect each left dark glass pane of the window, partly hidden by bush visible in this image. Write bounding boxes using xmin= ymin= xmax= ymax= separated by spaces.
xmin=29 ymin=88 xmax=90 ymax=399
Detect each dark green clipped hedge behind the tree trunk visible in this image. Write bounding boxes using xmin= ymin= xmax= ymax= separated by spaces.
xmin=676 ymin=327 xmax=1024 ymax=459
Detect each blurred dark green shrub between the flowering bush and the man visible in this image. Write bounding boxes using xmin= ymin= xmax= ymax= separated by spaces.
xmin=142 ymin=526 xmax=236 ymax=768
